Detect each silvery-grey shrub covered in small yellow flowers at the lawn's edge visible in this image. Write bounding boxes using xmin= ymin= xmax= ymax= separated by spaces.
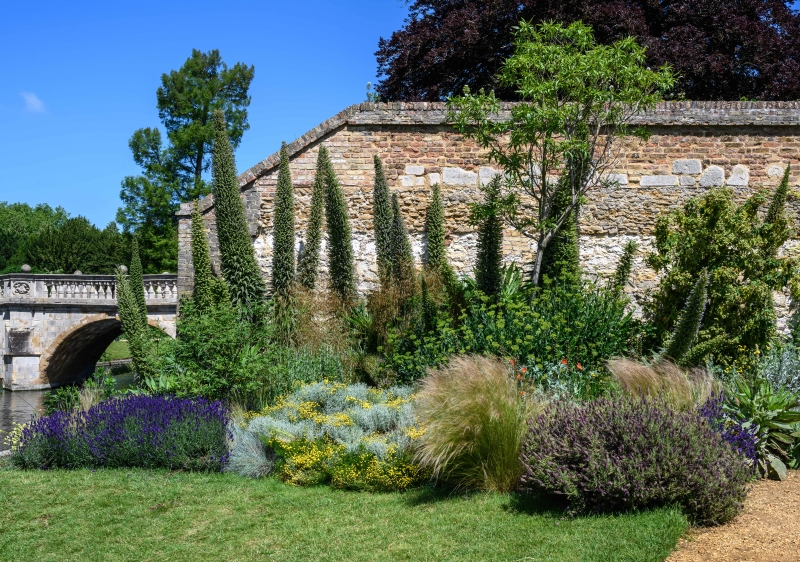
xmin=229 ymin=381 xmax=429 ymax=491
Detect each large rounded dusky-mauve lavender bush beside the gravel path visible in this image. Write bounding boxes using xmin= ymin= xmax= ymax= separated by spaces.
xmin=522 ymin=395 xmax=753 ymax=525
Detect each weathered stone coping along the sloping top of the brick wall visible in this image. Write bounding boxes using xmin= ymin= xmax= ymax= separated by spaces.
xmin=176 ymin=101 xmax=800 ymax=217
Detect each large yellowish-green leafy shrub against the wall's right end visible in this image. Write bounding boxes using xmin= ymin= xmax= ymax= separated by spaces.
xmin=645 ymin=188 xmax=798 ymax=363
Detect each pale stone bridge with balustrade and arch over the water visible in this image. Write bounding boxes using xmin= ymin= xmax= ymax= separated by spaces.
xmin=0 ymin=273 xmax=178 ymax=390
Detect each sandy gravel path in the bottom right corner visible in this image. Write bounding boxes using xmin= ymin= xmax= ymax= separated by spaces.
xmin=667 ymin=470 xmax=800 ymax=562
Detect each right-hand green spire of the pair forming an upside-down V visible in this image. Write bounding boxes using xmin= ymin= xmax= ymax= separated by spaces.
xmin=325 ymin=149 xmax=356 ymax=305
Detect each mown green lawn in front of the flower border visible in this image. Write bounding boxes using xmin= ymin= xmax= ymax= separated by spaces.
xmin=0 ymin=469 xmax=686 ymax=562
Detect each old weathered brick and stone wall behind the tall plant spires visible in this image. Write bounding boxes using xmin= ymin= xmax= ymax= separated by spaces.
xmin=178 ymin=102 xmax=800 ymax=320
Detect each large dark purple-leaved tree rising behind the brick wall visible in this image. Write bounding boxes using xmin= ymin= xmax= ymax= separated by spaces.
xmin=375 ymin=0 xmax=800 ymax=101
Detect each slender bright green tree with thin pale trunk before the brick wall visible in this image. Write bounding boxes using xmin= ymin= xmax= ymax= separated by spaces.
xmin=448 ymin=21 xmax=674 ymax=284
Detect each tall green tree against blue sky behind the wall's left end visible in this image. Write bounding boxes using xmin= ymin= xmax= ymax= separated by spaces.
xmin=117 ymin=50 xmax=255 ymax=273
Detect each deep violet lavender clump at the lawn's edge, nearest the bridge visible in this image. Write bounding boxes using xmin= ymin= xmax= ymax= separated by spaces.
xmin=11 ymin=395 xmax=229 ymax=471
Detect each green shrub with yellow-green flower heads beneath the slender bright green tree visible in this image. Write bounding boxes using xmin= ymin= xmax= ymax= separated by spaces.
xmin=383 ymin=276 xmax=643 ymax=390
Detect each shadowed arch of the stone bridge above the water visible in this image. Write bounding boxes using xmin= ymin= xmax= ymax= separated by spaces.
xmin=39 ymin=313 xmax=169 ymax=386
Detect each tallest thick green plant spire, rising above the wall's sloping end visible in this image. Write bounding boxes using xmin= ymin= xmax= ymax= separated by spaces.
xmin=211 ymin=110 xmax=266 ymax=308
